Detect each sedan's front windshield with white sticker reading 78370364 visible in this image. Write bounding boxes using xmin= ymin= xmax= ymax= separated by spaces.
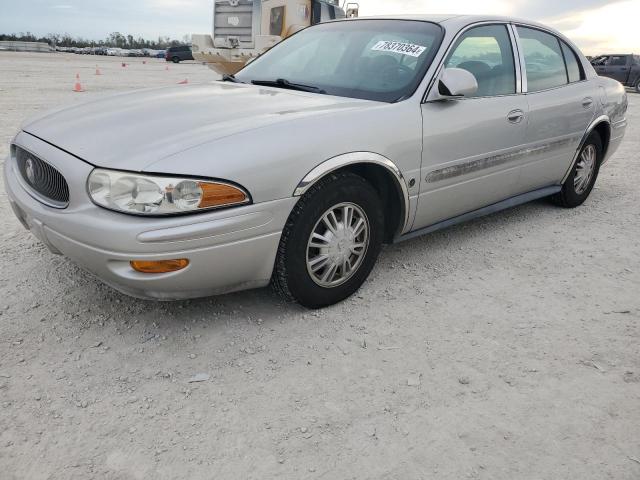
xmin=235 ymin=20 xmax=443 ymax=102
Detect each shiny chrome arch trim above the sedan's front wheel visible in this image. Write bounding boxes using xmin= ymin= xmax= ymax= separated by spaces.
xmin=293 ymin=152 xmax=410 ymax=233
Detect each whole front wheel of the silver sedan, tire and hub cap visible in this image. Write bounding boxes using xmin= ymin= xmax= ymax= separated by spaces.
xmin=271 ymin=172 xmax=384 ymax=308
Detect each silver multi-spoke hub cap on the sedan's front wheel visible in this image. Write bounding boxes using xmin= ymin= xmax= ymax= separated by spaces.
xmin=307 ymin=203 xmax=369 ymax=287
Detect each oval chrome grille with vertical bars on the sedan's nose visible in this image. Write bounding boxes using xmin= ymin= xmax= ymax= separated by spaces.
xmin=15 ymin=147 xmax=69 ymax=208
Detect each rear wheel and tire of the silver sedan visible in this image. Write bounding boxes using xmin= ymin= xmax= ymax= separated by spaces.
xmin=551 ymin=132 xmax=602 ymax=208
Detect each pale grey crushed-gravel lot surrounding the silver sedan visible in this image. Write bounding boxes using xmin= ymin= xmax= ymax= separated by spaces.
xmin=0 ymin=52 xmax=640 ymax=480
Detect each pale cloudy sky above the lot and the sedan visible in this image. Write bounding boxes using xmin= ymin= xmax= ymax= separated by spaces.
xmin=0 ymin=0 xmax=640 ymax=54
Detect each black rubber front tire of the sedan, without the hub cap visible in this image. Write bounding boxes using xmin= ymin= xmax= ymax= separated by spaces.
xmin=271 ymin=172 xmax=384 ymax=308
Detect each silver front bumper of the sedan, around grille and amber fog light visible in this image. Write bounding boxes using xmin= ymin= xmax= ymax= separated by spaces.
xmin=4 ymin=132 xmax=297 ymax=300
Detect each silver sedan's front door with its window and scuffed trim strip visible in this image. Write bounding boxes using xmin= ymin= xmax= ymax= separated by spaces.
xmin=413 ymin=24 xmax=528 ymax=229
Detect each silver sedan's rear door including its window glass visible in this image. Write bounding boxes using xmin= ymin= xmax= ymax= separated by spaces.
xmin=515 ymin=25 xmax=596 ymax=193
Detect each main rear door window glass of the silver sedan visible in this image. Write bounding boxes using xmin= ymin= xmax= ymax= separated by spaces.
xmin=517 ymin=27 xmax=567 ymax=92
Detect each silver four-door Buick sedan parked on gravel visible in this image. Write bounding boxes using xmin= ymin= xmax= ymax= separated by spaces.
xmin=5 ymin=16 xmax=627 ymax=308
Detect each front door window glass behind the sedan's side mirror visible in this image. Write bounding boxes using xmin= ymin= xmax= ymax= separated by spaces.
xmin=445 ymin=25 xmax=516 ymax=97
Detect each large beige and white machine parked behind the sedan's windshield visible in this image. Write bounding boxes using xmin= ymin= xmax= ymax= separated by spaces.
xmin=191 ymin=0 xmax=359 ymax=75
